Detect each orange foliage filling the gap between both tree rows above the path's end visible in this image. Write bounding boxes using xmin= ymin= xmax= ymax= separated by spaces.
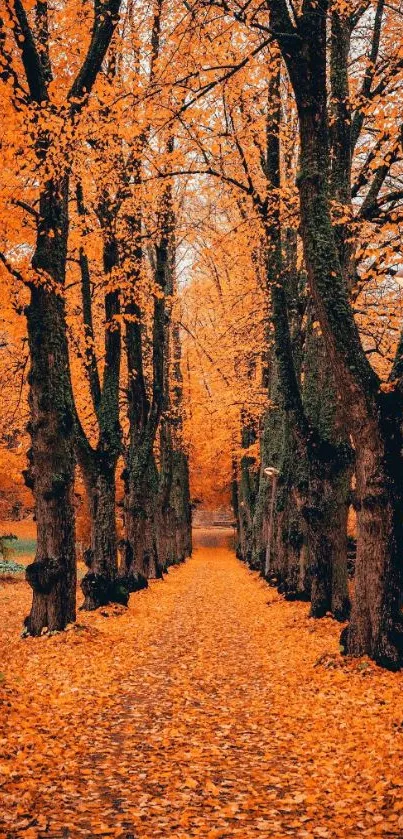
xmin=181 ymin=189 xmax=267 ymax=507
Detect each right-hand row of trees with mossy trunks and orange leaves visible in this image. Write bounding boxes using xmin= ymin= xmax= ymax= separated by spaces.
xmin=179 ymin=0 xmax=403 ymax=668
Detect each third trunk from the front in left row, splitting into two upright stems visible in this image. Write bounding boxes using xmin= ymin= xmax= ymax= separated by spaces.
xmin=122 ymin=154 xmax=173 ymax=590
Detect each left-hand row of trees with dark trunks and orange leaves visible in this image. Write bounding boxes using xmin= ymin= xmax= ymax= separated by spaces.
xmin=0 ymin=0 xmax=191 ymax=635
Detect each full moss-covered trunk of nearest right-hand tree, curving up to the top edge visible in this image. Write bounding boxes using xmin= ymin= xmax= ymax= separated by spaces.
xmin=271 ymin=0 xmax=403 ymax=668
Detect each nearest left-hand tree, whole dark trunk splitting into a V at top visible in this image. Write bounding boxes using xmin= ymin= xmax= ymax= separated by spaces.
xmin=1 ymin=0 xmax=120 ymax=635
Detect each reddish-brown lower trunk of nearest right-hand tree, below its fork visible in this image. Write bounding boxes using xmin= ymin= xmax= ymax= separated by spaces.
xmin=341 ymin=410 xmax=403 ymax=669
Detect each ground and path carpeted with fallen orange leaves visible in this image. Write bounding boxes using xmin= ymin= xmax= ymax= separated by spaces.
xmin=0 ymin=533 xmax=403 ymax=839
